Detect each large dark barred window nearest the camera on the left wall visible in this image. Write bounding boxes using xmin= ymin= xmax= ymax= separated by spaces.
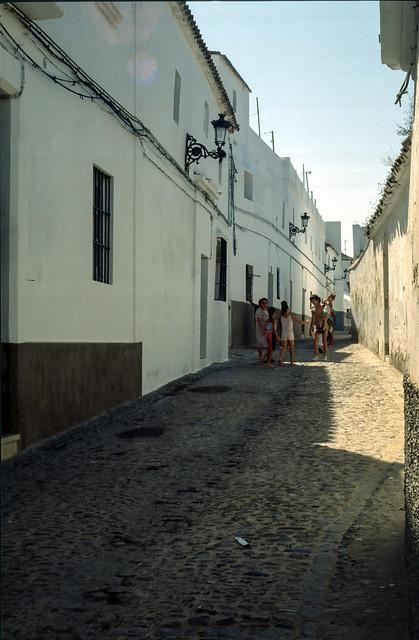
xmin=93 ymin=167 xmax=113 ymax=284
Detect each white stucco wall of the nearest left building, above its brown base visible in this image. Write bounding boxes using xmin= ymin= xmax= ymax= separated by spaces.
xmin=0 ymin=3 xmax=231 ymax=393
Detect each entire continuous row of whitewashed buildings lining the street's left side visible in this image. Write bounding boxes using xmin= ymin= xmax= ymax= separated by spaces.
xmin=0 ymin=1 xmax=342 ymax=451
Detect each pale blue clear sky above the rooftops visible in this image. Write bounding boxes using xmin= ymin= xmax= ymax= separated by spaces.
xmin=188 ymin=0 xmax=409 ymax=254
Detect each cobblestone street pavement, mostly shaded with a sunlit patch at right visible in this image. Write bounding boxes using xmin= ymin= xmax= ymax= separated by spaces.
xmin=2 ymin=340 xmax=407 ymax=640
